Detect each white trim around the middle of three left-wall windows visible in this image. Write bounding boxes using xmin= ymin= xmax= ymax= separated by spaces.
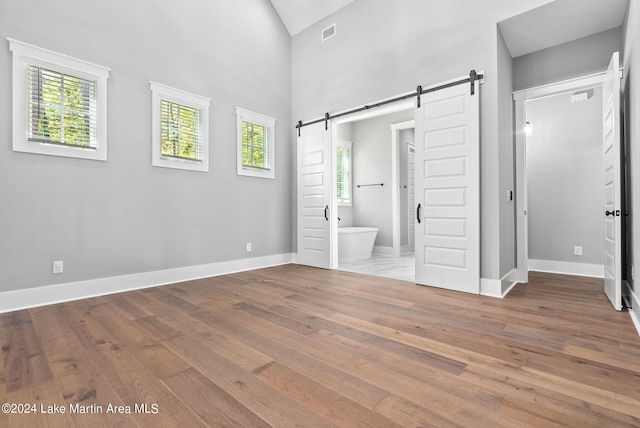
xmin=149 ymin=81 xmax=211 ymax=172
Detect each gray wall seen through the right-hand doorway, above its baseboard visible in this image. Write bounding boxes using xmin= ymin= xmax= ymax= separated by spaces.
xmin=526 ymin=88 xmax=604 ymax=264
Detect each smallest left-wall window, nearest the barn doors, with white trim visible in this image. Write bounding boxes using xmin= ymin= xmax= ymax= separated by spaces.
xmin=236 ymin=107 xmax=276 ymax=178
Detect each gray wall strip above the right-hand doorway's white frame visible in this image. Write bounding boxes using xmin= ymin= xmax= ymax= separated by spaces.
xmin=513 ymin=28 xmax=622 ymax=90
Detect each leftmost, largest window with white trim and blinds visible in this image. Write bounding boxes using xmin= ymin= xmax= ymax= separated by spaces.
xmin=9 ymin=39 xmax=109 ymax=161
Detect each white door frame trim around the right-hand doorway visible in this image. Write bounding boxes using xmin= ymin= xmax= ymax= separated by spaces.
xmin=513 ymin=72 xmax=605 ymax=283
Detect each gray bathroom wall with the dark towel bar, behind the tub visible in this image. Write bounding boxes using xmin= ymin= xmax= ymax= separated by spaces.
xmin=352 ymin=109 xmax=414 ymax=247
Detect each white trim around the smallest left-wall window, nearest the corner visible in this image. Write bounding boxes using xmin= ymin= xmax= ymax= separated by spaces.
xmin=236 ymin=107 xmax=276 ymax=179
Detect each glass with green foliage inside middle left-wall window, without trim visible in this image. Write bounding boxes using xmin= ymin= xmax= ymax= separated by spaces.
xmin=160 ymin=100 xmax=202 ymax=160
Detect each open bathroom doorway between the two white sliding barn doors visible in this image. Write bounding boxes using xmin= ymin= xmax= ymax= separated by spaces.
xmin=333 ymin=103 xmax=415 ymax=282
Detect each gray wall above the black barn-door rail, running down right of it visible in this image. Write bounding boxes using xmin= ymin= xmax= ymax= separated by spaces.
xmin=292 ymin=0 xmax=549 ymax=279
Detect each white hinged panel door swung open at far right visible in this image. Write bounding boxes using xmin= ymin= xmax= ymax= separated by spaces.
xmin=602 ymin=52 xmax=622 ymax=311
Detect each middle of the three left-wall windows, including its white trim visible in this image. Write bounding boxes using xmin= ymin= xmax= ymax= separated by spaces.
xmin=150 ymin=82 xmax=211 ymax=172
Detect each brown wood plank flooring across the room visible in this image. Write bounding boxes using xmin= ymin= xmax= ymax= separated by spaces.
xmin=0 ymin=265 xmax=640 ymax=428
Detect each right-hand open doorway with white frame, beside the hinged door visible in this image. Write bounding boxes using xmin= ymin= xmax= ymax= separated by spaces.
xmin=514 ymin=70 xmax=624 ymax=292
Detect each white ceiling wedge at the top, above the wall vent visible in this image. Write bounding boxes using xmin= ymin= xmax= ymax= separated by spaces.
xmin=271 ymin=0 xmax=353 ymax=36
